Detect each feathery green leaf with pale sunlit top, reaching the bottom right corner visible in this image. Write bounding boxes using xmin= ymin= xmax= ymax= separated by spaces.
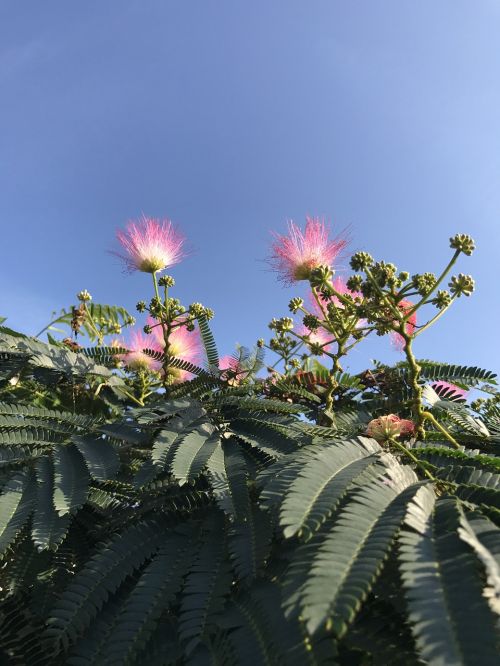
xmin=400 ymin=490 xmax=498 ymax=666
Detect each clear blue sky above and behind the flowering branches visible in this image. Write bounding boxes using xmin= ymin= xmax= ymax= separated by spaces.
xmin=0 ymin=0 xmax=500 ymax=370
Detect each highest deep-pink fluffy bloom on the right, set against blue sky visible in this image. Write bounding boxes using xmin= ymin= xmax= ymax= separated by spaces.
xmin=270 ymin=217 xmax=347 ymax=284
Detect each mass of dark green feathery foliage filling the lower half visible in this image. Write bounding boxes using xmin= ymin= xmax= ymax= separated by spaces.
xmin=0 ymin=332 xmax=500 ymax=666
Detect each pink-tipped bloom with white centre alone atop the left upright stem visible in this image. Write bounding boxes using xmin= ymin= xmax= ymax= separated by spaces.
xmin=114 ymin=215 xmax=185 ymax=273
